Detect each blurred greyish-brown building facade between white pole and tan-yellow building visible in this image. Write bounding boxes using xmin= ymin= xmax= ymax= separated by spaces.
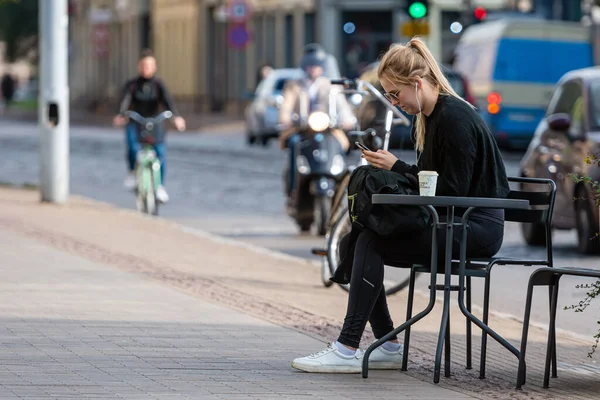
xmin=69 ymin=0 xmax=150 ymax=110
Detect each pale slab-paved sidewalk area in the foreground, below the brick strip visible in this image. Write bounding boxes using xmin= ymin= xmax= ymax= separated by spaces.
xmin=0 ymin=231 xmax=471 ymax=400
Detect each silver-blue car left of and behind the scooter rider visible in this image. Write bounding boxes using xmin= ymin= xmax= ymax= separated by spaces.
xmin=245 ymin=68 xmax=304 ymax=145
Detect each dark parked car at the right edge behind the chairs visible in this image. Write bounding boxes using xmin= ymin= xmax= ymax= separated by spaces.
xmin=521 ymin=67 xmax=600 ymax=254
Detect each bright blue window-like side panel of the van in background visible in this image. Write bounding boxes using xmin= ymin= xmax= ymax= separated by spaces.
xmin=494 ymin=38 xmax=592 ymax=84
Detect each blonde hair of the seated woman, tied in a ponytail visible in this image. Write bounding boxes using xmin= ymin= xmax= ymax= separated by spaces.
xmin=377 ymin=36 xmax=473 ymax=152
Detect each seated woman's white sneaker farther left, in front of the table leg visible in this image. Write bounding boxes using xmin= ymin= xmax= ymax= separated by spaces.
xmin=292 ymin=343 xmax=363 ymax=374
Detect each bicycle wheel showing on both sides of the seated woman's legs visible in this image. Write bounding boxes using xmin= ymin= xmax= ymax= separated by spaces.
xmin=327 ymin=212 xmax=418 ymax=296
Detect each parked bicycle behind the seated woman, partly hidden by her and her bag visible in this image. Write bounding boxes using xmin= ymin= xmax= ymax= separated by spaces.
xmin=312 ymin=79 xmax=418 ymax=295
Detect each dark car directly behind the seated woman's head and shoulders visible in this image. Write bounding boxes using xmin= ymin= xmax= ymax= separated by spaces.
xmin=357 ymin=61 xmax=475 ymax=149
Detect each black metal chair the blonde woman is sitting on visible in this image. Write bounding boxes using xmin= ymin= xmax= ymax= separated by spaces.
xmin=401 ymin=177 xmax=556 ymax=379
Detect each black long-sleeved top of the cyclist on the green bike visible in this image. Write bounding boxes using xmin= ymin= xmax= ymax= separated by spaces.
xmin=119 ymin=76 xmax=178 ymax=117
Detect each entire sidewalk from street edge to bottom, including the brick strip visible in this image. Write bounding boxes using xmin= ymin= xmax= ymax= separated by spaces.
xmin=0 ymin=189 xmax=600 ymax=399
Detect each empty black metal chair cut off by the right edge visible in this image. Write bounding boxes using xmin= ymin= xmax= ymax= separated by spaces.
xmin=517 ymin=267 xmax=600 ymax=389
